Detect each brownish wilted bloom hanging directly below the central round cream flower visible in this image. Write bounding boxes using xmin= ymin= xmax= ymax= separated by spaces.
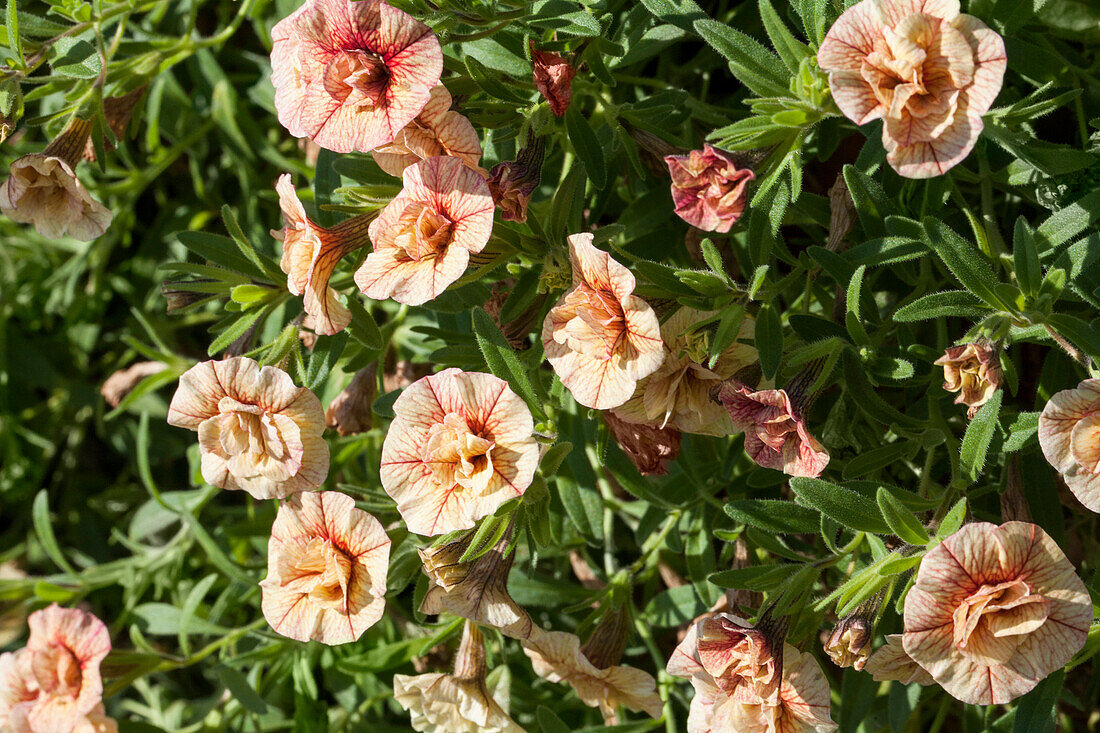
xmin=417 ymin=521 xmax=531 ymax=639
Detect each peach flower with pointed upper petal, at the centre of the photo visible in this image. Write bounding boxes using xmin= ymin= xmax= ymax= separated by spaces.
xmin=542 ymin=233 xmax=664 ymax=409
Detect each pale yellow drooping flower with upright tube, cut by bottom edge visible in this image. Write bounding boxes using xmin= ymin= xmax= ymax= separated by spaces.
xmin=394 ymin=621 xmax=524 ymax=733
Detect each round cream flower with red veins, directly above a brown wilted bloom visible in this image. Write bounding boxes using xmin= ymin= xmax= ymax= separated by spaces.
xmin=381 ymin=369 xmax=539 ymax=536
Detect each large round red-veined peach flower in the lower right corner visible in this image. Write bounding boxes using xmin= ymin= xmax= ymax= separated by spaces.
xmin=902 ymin=522 xmax=1092 ymax=705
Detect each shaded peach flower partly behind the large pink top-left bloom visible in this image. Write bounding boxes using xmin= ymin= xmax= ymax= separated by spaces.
xmin=371 ymin=84 xmax=481 ymax=176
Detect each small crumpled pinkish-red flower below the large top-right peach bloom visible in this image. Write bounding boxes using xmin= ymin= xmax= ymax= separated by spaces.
xmin=664 ymin=143 xmax=756 ymax=233
